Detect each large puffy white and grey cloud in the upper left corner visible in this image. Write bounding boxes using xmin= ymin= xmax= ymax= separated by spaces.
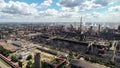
xmin=1 ymin=1 xmax=37 ymax=15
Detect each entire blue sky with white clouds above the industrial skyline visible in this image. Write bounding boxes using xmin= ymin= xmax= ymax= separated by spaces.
xmin=0 ymin=0 xmax=120 ymax=23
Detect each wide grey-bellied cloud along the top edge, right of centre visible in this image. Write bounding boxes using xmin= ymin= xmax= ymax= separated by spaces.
xmin=57 ymin=0 xmax=116 ymax=12
